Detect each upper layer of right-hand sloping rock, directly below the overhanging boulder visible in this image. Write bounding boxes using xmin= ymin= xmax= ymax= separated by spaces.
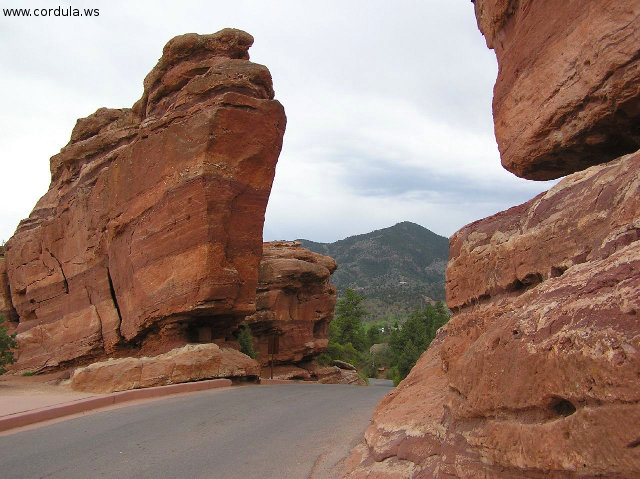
xmin=447 ymin=152 xmax=640 ymax=311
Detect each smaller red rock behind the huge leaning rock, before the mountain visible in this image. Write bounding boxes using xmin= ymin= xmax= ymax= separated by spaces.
xmin=245 ymin=241 xmax=337 ymax=366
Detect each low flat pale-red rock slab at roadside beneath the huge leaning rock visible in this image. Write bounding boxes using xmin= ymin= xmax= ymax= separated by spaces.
xmin=70 ymin=343 xmax=260 ymax=393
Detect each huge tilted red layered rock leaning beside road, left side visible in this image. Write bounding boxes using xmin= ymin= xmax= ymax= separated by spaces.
xmin=6 ymin=29 xmax=286 ymax=376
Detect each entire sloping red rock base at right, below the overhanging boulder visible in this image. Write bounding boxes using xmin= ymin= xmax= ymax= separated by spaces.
xmin=347 ymin=152 xmax=640 ymax=478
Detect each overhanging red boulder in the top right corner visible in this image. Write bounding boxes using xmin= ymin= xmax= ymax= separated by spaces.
xmin=474 ymin=0 xmax=640 ymax=180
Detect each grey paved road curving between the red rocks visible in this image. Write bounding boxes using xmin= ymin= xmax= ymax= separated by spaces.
xmin=0 ymin=380 xmax=390 ymax=479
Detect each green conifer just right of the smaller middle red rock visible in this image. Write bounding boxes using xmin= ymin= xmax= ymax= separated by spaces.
xmin=329 ymin=288 xmax=369 ymax=351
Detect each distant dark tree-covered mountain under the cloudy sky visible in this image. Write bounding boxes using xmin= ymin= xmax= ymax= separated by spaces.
xmin=298 ymin=221 xmax=449 ymax=320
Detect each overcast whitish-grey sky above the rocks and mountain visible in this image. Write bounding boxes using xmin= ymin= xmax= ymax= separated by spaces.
xmin=0 ymin=0 xmax=552 ymax=242
